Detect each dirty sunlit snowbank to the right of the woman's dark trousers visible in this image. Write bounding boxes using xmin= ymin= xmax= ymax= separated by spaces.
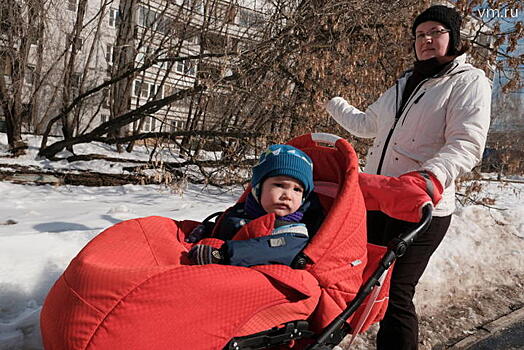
xmin=417 ymin=193 xmax=524 ymax=308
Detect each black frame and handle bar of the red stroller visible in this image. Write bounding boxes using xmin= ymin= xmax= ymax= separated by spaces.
xmin=224 ymin=205 xmax=433 ymax=350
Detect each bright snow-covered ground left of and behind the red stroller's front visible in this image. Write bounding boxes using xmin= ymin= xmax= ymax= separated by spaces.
xmin=0 ymin=183 xmax=240 ymax=349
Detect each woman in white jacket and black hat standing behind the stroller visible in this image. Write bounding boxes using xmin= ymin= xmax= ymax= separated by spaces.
xmin=326 ymin=5 xmax=491 ymax=350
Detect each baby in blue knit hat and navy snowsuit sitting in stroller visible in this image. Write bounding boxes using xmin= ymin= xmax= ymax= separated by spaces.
xmin=189 ymin=144 xmax=322 ymax=266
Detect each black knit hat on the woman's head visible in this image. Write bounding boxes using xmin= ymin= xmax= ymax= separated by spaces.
xmin=411 ymin=5 xmax=462 ymax=56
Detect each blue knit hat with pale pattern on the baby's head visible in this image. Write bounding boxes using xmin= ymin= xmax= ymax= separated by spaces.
xmin=251 ymin=144 xmax=314 ymax=200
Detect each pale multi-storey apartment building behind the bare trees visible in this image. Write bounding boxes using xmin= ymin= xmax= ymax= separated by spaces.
xmin=0 ymin=0 xmax=267 ymax=134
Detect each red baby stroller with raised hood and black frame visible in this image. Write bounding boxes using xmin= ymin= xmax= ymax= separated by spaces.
xmin=41 ymin=134 xmax=432 ymax=350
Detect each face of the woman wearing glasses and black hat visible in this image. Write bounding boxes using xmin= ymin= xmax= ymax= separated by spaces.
xmin=415 ymin=21 xmax=449 ymax=61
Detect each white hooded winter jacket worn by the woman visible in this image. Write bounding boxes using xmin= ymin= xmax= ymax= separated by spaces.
xmin=326 ymin=55 xmax=491 ymax=216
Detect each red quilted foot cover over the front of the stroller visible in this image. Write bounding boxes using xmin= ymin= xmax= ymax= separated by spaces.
xmin=41 ymin=217 xmax=319 ymax=349
